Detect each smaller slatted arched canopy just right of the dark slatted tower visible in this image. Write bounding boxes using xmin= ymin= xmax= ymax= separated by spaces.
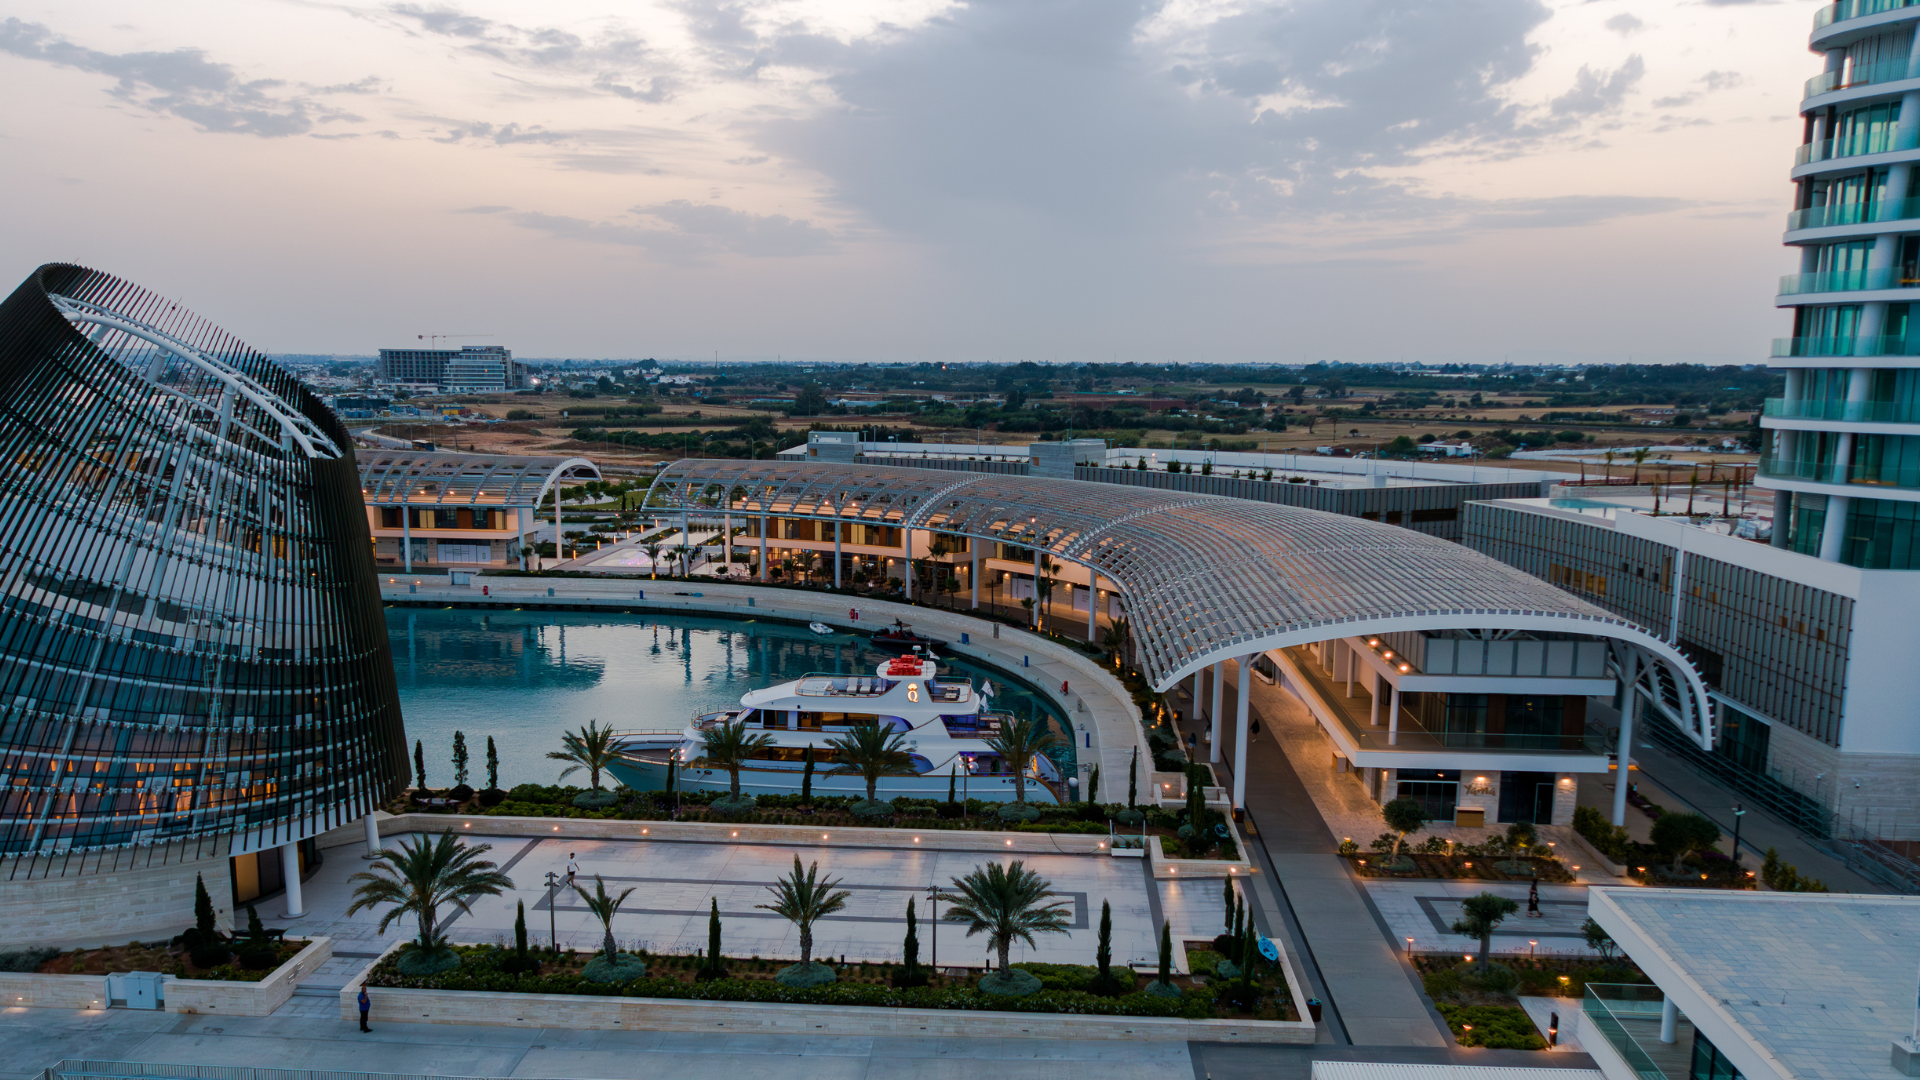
xmin=357 ymin=450 xmax=601 ymax=507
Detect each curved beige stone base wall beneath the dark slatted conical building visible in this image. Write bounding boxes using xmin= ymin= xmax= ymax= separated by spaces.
xmin=0 ymin=842 xmax=232 ymax=947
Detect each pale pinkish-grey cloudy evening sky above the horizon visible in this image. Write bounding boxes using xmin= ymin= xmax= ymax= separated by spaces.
xmin=0 ymin=0 xmax=1820 ymax=363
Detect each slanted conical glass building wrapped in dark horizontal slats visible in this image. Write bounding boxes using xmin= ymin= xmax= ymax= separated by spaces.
xmin=0 ymin=265 xmax=407 ymax=940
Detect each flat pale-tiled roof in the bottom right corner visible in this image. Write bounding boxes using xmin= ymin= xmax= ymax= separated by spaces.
xmin=1588 ymin=888 xmax=1920 ymax=1080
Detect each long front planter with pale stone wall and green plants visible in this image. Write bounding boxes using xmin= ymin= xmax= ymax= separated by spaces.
xmin=340 ymin=945 xmax=1313 ymax=1043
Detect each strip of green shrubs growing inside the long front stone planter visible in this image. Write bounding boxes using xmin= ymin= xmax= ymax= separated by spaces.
xmin=367 ymin=945 xmax=1296 ymax=1020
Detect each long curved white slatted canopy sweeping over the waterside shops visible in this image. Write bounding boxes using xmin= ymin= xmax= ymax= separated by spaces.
xmin=647 ymin=451 xmax=1713 ymax=746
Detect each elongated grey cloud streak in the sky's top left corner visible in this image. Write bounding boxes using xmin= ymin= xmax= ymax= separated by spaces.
xmin=0 ymin=17 xmax=343 ymax=138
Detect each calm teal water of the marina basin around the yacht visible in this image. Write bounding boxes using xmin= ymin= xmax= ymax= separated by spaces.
xmin=386 ymin=607 xmax=1064 ymax=788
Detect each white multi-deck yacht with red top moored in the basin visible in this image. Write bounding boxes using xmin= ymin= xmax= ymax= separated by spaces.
xmin=609 ymin=655 xmax=1064 ymax=801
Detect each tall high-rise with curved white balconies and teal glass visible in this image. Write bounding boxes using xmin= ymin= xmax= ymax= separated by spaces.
xmin=1761 ymin=0 xmax=1920 ymax=569
